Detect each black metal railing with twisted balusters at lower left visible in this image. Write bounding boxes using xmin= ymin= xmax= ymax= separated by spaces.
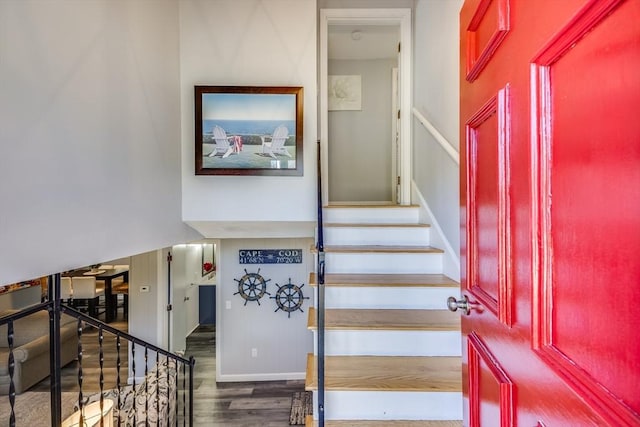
xmin=0 ymin=274 xmax=195 ymax=427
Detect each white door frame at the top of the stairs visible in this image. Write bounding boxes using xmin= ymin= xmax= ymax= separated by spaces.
xmin=318 ymin=8 xmax=413 ymax=205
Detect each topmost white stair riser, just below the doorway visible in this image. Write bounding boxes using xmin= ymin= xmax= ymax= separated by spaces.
xmin=322 ymin=207 xmax=419 ymax=224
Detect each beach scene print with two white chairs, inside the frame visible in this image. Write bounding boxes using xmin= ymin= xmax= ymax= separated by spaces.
xmin=201 ymin=93 xmax=297 ymax=170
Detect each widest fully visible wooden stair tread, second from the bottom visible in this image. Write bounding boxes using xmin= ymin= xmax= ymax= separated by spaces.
xmin=306 ymin=354 xmax=462 ymax=392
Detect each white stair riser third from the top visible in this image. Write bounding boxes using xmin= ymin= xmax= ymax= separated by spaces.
xmin=325 ymin=252 xmax=442 ymax=274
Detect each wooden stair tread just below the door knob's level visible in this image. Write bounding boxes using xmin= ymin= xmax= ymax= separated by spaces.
xmin=307 ymin=307 xmax=460 ymax=331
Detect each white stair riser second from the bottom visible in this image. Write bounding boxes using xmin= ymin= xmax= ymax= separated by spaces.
xmin=314 ymin=329 xmax=462 ymax=356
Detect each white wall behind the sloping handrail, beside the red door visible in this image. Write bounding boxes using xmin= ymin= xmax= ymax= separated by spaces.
xmin=413 ymin=0 xmax=462 ymax=278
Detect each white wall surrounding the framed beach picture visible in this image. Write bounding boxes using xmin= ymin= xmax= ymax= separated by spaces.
xmin=179 ymin=0 xmax=317 ymax=238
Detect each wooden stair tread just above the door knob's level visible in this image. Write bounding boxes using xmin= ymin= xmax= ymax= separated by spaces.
xmin=309 ymin=273 xmax=460 ymax=288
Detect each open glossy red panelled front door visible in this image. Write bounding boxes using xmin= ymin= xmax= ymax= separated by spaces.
xmin=460 ymin=0 xmax=640 ymax=427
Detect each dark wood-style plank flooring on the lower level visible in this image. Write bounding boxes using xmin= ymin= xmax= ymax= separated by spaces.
xmin=30 ymin=317 xmax=304 ymax=427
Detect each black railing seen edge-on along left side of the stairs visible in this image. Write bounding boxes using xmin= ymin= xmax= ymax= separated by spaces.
xmin=316 ymin=140 xmax=325 ymax=427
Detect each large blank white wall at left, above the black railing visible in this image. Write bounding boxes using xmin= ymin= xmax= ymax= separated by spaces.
xmin=0 ymin=0 xmax=200 ymax=284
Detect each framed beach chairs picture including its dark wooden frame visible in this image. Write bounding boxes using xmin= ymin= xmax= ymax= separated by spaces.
xmin=195 ymin=86 xmax=303 ymax=176
